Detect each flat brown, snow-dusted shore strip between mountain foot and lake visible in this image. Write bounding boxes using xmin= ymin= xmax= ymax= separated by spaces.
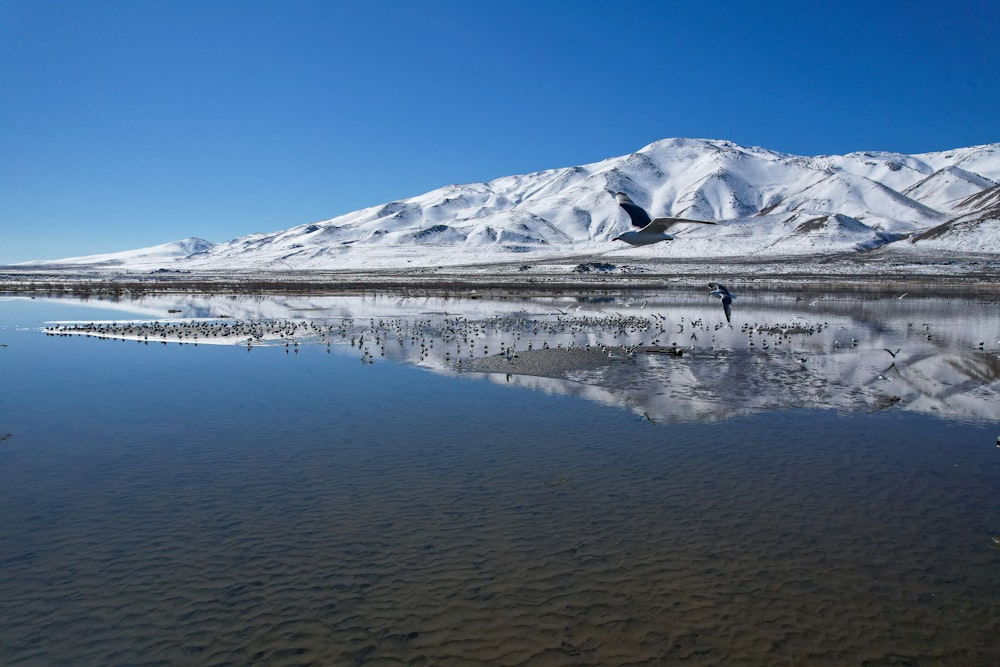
xmin=0 ymin=251 xmax=1000 ymax=298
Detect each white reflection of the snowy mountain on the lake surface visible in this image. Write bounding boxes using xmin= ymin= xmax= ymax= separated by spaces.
xmin=37 ymin=290 xmax=1000 ymax=421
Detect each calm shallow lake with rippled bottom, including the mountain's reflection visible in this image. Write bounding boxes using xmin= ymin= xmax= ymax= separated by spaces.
xmin=0 ymin=294 xmax=1000 ymax=665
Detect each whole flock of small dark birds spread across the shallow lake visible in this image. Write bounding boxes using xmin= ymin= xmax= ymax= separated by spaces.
xmin=37 ymin=290 xmax=989 ymax=430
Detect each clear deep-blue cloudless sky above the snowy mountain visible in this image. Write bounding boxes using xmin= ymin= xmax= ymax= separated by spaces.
xmin=0 ymin=0 xmax=1000 ymax=264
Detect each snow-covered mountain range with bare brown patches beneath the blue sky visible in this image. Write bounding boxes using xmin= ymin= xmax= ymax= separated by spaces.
xmin=17 ymin=139 xmax=1000 ymax=270
